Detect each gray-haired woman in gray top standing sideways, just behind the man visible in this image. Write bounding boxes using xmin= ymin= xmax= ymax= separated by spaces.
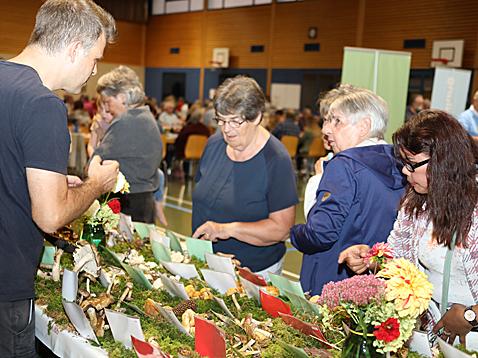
xmin=94 ymin=66 xmax=162 ymax=223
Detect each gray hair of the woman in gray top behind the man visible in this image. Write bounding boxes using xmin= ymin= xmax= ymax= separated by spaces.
xmin=96 ymin=66 xmax=146 ymax=107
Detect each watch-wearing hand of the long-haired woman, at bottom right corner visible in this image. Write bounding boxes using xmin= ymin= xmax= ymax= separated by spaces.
xmin=433 ymin=303 xmax=472 ymax=346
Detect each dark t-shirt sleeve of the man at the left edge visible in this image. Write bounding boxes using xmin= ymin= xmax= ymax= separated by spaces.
xmin=17 ymin=97 xmax=70 ymax=175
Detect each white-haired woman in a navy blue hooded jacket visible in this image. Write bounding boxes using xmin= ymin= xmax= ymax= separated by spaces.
xmin=291 ymin=86 xmax=404 ymax=294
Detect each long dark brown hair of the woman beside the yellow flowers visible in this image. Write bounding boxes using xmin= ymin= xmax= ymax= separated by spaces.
xmin=393 ymin=110 xmax=478 ymax=247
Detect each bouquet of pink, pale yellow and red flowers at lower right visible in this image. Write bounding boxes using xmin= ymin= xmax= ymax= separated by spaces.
xmin=318 ymin=242 xmax=433 ymax=358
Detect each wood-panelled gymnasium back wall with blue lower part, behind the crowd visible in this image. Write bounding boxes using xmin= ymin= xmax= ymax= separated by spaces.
xmin=0 ymin=0 xmax=478 ymax=100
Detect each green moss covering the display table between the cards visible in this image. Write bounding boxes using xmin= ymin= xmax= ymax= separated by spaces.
xmin=36 ymin=242 xmax=338 ymax=358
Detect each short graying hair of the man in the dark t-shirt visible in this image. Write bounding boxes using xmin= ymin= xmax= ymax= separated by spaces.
xmin=28 ymin=0 xmax=117 ymax=54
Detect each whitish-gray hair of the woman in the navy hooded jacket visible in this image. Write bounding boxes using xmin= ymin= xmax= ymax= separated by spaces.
xmin=329 ymin=86 xmax=388 ymax=139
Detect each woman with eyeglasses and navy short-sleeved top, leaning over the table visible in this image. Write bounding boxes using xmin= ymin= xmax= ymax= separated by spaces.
xmin=192 ymin=76 xmax=298 ymax=278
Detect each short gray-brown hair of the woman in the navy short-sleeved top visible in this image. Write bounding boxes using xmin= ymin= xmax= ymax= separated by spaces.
xmin=214 ymin=76 xmax=266 ymax=121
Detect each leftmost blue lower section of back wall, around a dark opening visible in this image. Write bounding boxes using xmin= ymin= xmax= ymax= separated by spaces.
xmin=145 ymin=67 xmax=199 ymax=102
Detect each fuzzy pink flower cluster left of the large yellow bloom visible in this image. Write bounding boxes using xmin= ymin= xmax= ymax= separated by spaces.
xmin=317 ymin=275 xmax=386 ymax=308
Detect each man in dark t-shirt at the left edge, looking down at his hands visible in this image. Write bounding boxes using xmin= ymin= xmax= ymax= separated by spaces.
xmin=0 ymin=0 xmax=119 ymax=358
